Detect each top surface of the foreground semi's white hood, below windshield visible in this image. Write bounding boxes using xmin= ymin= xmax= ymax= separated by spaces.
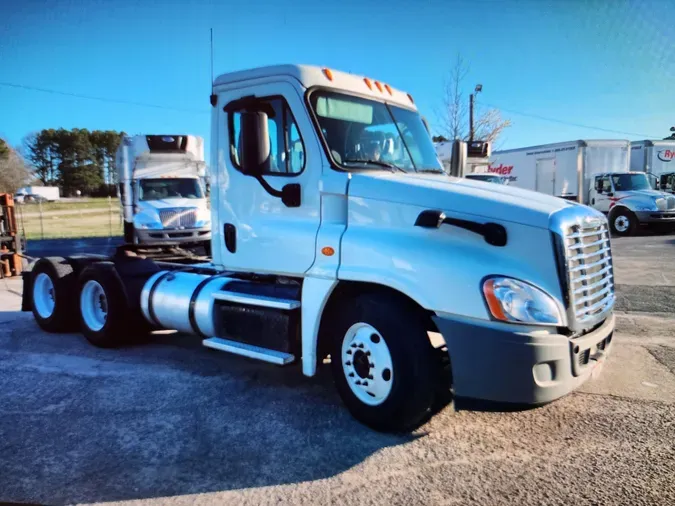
xmin=349 ymin=172 xmax=578 ymax=228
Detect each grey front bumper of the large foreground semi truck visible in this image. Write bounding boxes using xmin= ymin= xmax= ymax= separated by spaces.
xmin=434 ymin=314 xmax=614 ymax=404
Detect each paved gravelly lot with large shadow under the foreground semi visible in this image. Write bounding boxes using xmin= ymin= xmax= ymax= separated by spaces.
xmin=0 ymin=236 xmax=675 ymax=505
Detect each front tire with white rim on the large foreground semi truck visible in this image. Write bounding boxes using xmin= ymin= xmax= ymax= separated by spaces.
xmin=327 ymin=292 xmax=438 ymax=431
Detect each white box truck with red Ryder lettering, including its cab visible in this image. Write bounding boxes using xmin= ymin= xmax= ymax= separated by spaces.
xmin=476 ymin=140 xmax=675 ymax=235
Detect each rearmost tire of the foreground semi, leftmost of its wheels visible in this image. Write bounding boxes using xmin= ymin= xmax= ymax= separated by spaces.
xmin=30 ymin=257 xmax=77 ymax=332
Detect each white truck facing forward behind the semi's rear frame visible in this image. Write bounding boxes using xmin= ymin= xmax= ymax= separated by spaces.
xmin=115 ymin=135 xmax=211 ymax=244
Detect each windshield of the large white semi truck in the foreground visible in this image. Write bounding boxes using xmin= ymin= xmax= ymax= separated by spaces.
xmin=310 ymin=90 xmax=443 ymax=173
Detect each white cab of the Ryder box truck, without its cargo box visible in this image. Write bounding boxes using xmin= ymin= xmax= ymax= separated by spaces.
xmin=589 ymin=172 xmax=675 ymax=235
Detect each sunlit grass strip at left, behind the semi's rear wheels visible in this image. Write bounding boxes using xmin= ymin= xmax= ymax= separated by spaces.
xmin=19 ymin=209 xmax=122 ymax=240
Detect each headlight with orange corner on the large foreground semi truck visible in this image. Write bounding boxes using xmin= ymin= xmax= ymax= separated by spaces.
xmin=483 ymin=277 xmax=563 ymax=326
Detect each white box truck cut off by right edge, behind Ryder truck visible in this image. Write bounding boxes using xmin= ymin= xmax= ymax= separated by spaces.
xmin=630 ymin=140 xmax=675 ymax=193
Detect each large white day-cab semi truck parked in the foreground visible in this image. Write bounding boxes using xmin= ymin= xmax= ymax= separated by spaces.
xmin=23 ymin=65 xmax=614 ymax=430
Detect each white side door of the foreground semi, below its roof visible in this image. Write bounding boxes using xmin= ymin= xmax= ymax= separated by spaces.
xmin=217 ymin=82 xmax=321 ymax=276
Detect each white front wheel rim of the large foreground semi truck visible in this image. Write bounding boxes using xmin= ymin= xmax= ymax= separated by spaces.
xmin=341 ymin=323 xmax=394 ymax=406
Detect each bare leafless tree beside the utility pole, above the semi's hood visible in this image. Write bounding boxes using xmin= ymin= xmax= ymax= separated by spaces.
xmin=439 ymin=54 xmax=511 ymax=143
